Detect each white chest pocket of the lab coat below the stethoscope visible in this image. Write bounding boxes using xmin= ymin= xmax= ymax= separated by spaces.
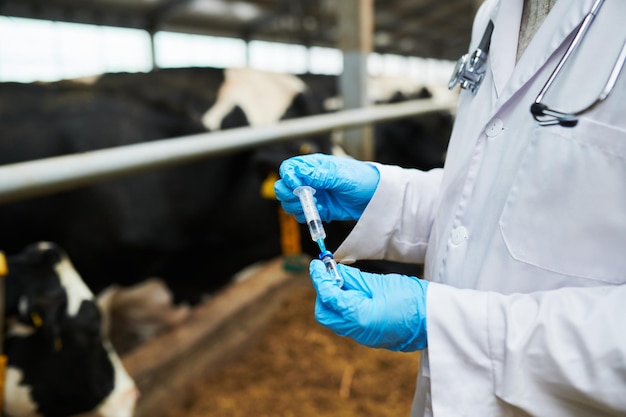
xmin=500 ymin=119 xmax=626 ymax=283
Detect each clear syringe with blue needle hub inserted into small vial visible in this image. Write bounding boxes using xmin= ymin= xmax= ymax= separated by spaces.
xmin=293 ymin=185 xmax=343 ymax=288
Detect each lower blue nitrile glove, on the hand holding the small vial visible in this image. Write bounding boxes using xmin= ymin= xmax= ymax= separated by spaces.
xmin=309 ymin=260 xmax=428 ymax=352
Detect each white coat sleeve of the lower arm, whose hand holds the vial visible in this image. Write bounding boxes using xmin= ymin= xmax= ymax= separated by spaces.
xmin=427 ymin=283 xmax=626 ymax=417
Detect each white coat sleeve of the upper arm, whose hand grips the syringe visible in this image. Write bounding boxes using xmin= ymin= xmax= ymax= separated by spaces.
xmin=335 ymin=164 xmax=443 ymax=263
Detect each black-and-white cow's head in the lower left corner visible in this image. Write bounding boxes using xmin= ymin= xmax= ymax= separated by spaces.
xmin=3 ymin=242 xmax=138 ymax=417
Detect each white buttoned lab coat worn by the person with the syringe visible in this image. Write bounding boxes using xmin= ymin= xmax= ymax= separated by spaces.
xmin=335 ymin=0 xmax=626 ymax=417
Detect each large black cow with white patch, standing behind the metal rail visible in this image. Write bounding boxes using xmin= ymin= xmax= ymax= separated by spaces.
xmin=0 ymin=69 xmax=330 ymax=303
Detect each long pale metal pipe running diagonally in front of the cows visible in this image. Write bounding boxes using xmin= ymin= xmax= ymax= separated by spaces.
xmin=0 ymin=100 xmax=451 ymax=204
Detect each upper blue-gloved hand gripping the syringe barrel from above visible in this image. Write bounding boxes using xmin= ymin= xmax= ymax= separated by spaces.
xmin=274 ymin=154 xmax=380 ymax=223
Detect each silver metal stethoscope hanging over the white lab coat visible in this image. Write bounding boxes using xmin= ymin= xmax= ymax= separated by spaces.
xmin=448 ymin=0 xmax=626 ymax=127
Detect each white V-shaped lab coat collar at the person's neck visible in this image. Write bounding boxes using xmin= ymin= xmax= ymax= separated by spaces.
xmin=489 ymin=0 xmax=595 ymax=107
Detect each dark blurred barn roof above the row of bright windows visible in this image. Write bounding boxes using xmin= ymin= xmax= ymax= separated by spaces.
xmin=0 ymin=0 xmax=480 ymax=60
